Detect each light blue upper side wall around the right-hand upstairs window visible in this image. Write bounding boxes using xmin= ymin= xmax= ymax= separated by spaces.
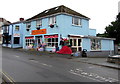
xmin=58 ymin=15 xmax=89 ymax=37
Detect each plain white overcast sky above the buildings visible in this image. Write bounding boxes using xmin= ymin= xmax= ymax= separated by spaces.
xmin=0 ymin=0 xmax=120 ymax=33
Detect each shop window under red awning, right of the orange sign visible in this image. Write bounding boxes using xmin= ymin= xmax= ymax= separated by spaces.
xmin=44 ymin=35 xmax=58 ymax=47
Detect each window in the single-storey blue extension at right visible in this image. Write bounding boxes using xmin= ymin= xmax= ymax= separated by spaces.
xmin=91 ymin=39 xmax=101 ymax=50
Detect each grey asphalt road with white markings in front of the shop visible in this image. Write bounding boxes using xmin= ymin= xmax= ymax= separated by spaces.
xmin=0 ymin=47 xmax=118 ymax=82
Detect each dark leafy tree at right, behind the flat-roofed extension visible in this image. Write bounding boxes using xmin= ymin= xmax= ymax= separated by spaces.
xmin=98 ymin=13 xmax=120 ymax=44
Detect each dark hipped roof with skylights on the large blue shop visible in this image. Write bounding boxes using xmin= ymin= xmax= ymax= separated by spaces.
xmin=26 ymin=5 xmax=90 ymax=21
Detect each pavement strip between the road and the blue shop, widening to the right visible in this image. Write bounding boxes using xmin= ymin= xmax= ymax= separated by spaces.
xmin=15 ymin=49 xmax=120 ymax=70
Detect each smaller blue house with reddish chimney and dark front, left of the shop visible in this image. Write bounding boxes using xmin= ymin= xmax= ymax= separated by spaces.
xmin=3 ymin=18 xmax=25 ymax=48
